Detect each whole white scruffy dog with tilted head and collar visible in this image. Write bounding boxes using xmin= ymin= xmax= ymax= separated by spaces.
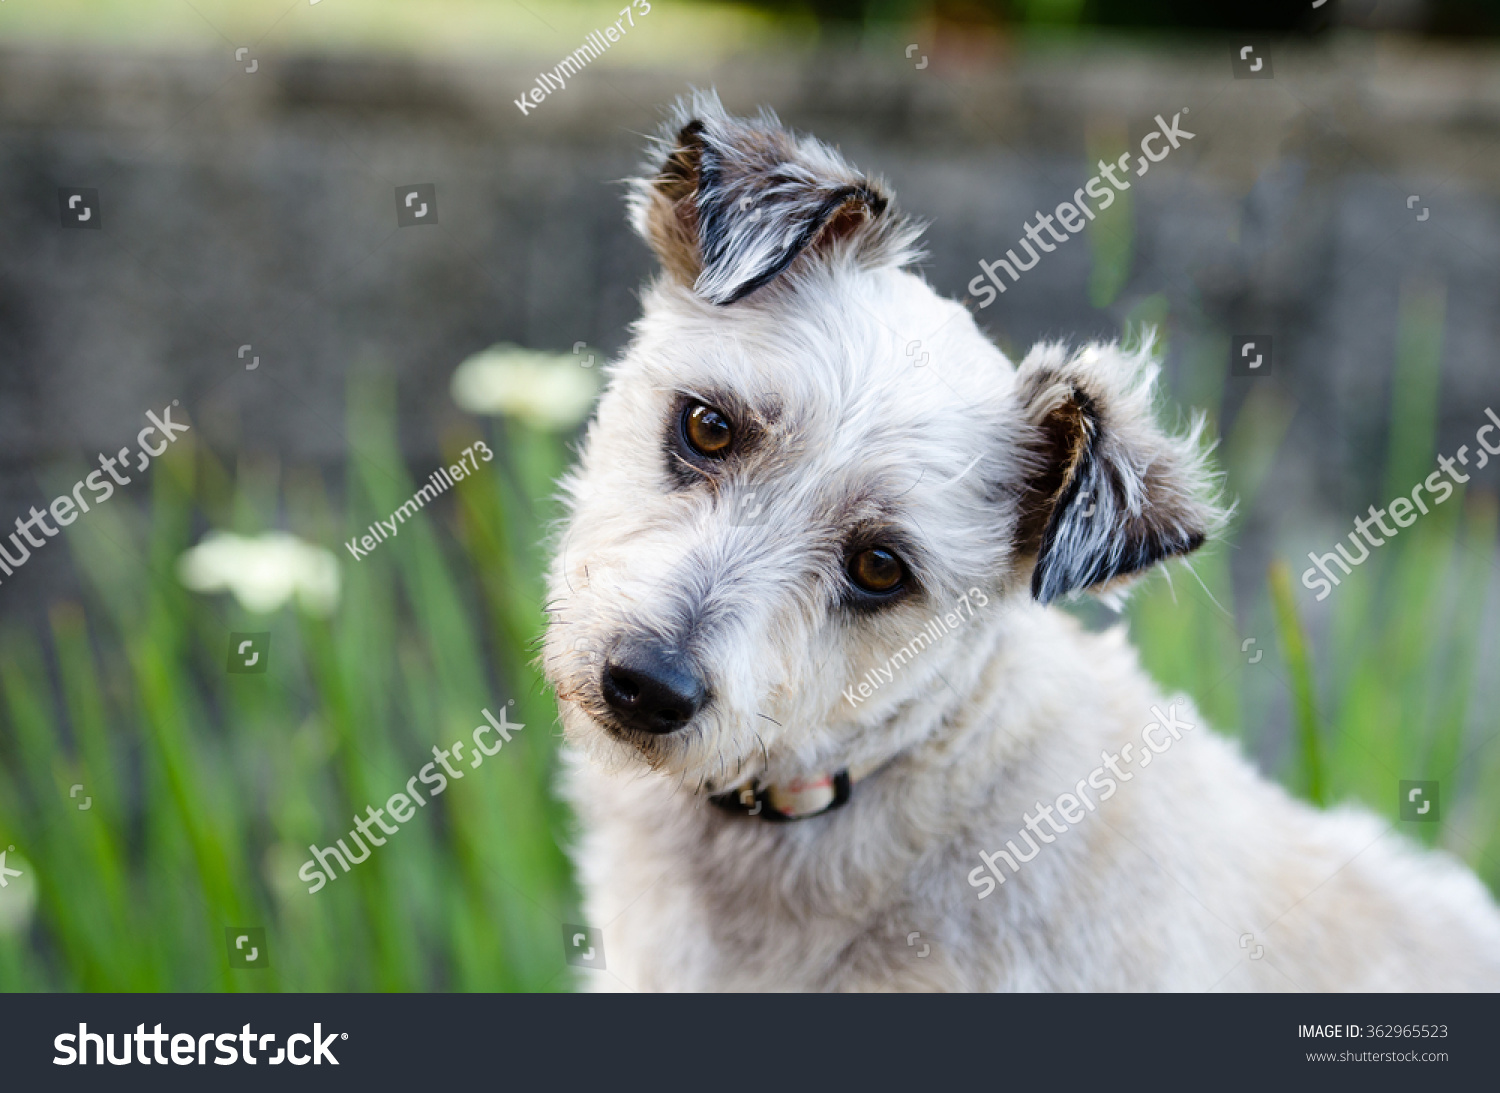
xmin=545 ymin=94 xmax=1500 ymax=991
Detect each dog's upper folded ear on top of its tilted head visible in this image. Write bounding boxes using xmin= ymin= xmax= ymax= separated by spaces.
xmin=630 ymin=93 xmax=920 ymax=306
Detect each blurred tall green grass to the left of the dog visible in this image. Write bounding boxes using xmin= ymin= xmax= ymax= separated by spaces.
xmin=0 ymin=368 xmax=576 ymax=991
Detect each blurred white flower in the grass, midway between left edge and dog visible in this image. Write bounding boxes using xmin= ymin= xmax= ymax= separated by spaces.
xmin=177 ymin=531 xmax=339 ymax=615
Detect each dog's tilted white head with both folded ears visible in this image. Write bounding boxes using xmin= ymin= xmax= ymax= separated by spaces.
xmin=543 ymin=94 xmax=1215 ymax=792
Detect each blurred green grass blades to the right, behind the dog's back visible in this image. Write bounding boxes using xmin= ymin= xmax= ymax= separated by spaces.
xmin=1128 ymin=272 xmax=1500 ymax=891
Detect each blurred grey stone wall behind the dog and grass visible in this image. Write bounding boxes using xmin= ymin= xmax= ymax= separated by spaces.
xmin=0 ymin=37 xmax=1500 ymax=610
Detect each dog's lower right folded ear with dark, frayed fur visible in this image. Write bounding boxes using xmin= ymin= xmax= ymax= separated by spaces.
xmin=1017 ymin=345 xmax=1223 ymax=603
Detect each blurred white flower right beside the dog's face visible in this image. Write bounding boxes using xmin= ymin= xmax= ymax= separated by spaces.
xmin=452 ymin=345 xmax=599 ymax=432
